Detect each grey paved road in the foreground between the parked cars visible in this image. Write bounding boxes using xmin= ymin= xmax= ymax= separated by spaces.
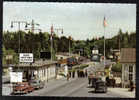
xmin=27 ymin=78 xmax=127 ymax=98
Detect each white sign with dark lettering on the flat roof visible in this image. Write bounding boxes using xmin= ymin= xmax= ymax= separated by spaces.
xmin=19 ymin=53 xmax=33 ymax=62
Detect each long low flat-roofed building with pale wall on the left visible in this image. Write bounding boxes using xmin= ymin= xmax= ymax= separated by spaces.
xmin=13 ymin=61 xmax=56 ymax=82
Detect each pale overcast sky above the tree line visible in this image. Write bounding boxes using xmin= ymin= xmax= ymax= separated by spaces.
xmin=3 ymin=2 xmax=136 ymax=40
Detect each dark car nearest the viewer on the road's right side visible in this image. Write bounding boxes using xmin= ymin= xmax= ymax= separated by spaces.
xmin=95 ymin=80 xmax=107 ymax=93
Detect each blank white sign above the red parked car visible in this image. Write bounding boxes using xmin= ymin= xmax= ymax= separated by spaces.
xmin=10 ymin=72 xmax=23 ymax=82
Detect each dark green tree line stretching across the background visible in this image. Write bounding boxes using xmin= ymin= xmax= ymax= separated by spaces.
xmin=2 ymin=29 xmax=136 ymax=62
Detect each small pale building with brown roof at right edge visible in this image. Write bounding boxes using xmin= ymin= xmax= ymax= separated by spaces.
xmin=120 ymin=48 xmax=136 ymax=87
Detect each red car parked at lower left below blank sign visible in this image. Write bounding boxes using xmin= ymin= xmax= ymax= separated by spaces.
xmin=13 ymin=82 xmax=34 ymax=94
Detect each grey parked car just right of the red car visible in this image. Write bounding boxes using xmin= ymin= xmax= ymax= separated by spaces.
xmin=30 ymin=79 xmax=45 ymax=89
